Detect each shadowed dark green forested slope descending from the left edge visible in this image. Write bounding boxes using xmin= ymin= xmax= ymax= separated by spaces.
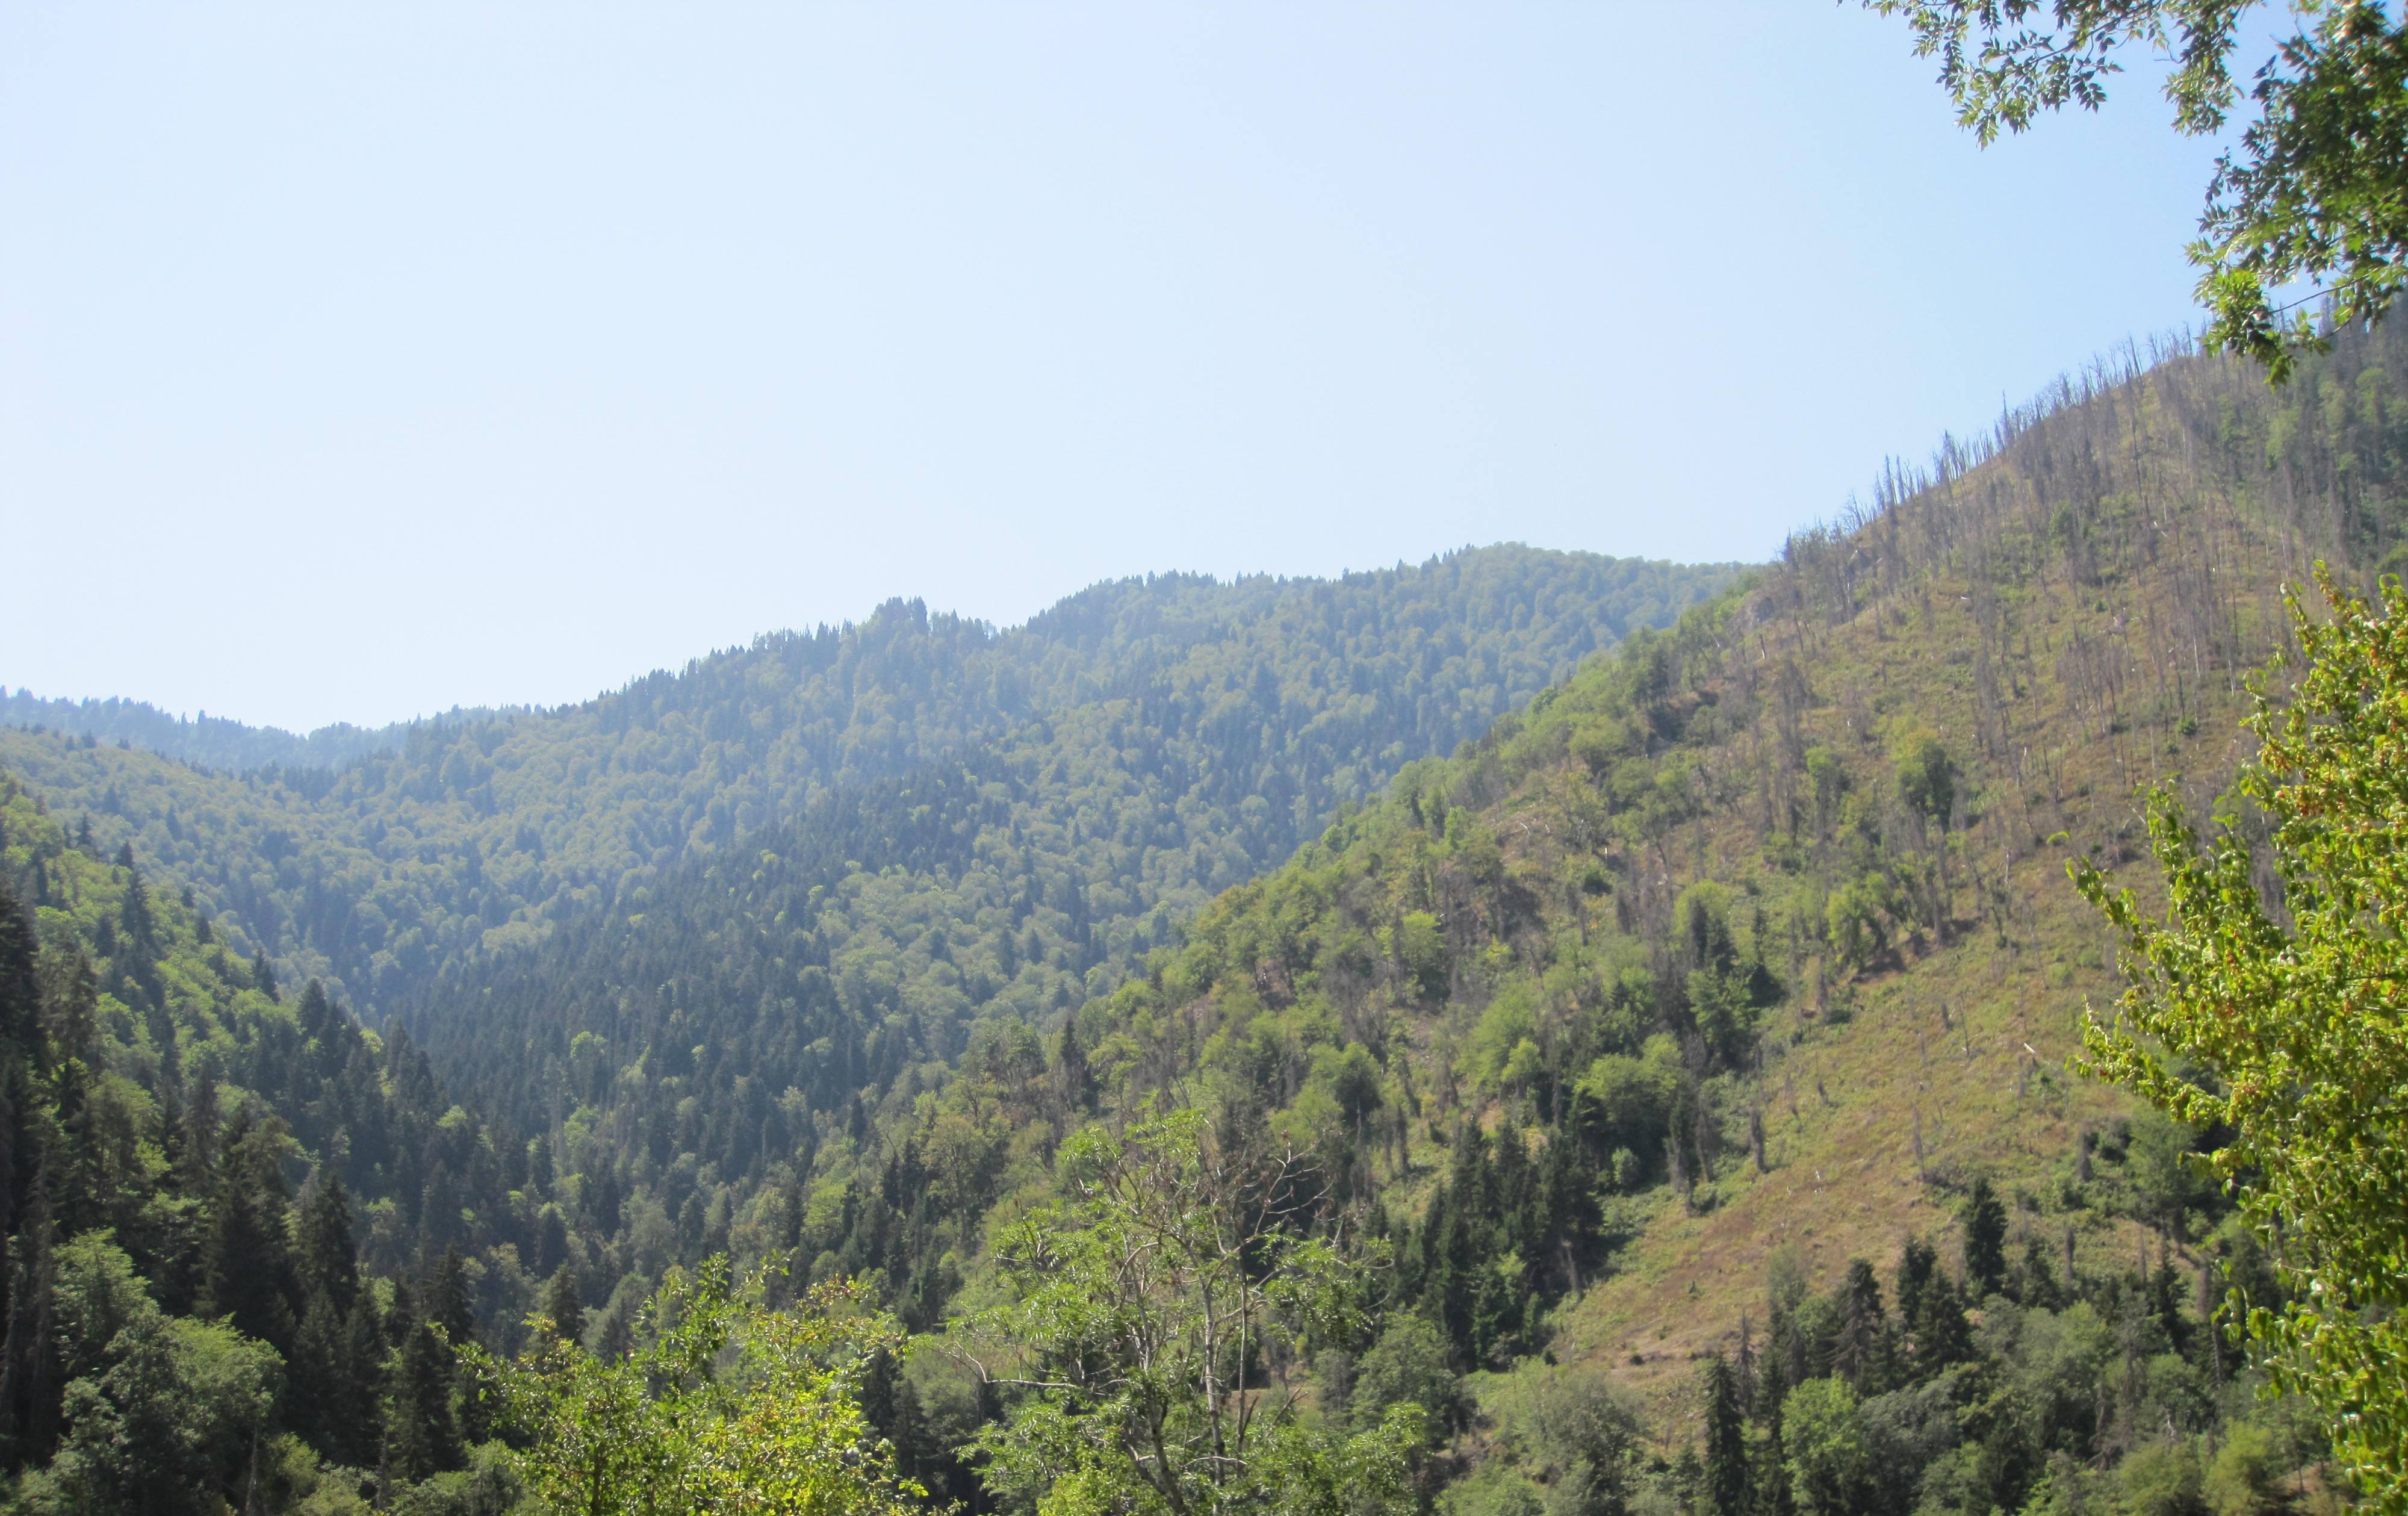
xmin=0 ymin=777 xmax=542 ymax=1514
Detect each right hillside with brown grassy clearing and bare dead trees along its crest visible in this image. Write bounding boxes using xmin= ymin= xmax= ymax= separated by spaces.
xmin=824 ymin=332 xmax=2408 ymax=1514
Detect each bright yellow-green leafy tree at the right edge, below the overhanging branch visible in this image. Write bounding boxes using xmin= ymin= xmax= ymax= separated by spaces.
xmin=2071 ymin=565 xmax=2408 ymax=1511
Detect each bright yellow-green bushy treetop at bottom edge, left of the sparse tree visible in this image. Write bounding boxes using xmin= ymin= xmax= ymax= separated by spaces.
xmin=474 ymin=1258 xmax=925 ymax=1516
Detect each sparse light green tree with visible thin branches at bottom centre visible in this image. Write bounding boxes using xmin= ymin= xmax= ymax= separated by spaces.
xmin=954 ymin=1112 xmax=1423 ymax=1516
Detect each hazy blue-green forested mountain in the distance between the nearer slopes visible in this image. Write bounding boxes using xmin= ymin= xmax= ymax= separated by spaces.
xmin=0 ymin=548 xmax=1729 ymax=1405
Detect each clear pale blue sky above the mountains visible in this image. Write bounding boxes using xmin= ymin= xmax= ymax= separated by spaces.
xmin=0 ymin=0 xmax=2211 ymax=727
